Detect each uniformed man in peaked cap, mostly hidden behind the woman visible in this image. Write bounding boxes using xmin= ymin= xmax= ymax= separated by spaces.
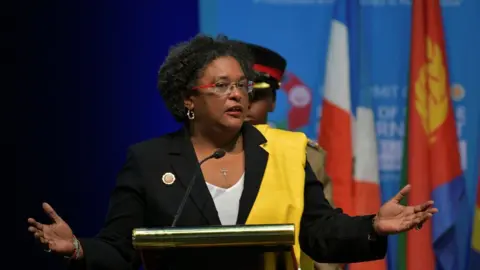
xmin=247 ymin=43 xmax=343 ymax=270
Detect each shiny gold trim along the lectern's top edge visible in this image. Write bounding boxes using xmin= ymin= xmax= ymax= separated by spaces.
xmin=132 ymin=224 xmax=295 ymax=249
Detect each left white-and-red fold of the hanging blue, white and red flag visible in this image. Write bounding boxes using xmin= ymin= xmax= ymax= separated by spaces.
xmin=318 ymin=0 xmax=353 ymax=217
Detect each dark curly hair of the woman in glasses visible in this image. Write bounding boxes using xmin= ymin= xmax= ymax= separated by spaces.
xmin=157 ymin=34 xmax=255 ymax=122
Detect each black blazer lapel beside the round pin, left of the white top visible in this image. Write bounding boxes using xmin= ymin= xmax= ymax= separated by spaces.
xmin=169 ymin=129 xmax=221 ymax=225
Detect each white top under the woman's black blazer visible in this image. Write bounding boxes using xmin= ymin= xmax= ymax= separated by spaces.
xmin=207 ymin=173 xmax=245 ymax=225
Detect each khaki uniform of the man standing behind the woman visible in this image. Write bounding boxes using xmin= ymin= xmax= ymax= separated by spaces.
xmin=307 ymin=140 xmax=343 ymax=270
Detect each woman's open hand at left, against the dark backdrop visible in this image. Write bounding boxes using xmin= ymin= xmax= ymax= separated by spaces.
xmin=28 ymin=203 xmax=76 ymax=256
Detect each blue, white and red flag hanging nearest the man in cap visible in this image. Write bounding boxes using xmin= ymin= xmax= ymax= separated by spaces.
xmin=319 ymin=0 xmax=386 ymax=270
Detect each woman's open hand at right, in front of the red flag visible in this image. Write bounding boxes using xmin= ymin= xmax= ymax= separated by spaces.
xmin=373 ymin=185 xmax=438 ymax=235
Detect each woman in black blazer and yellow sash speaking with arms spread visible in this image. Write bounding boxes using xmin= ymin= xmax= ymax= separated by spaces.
xmin=28 ymin=35 xmax=438 ymax=270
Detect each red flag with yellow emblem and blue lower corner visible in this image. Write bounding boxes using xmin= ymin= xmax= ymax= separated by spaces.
xmin=398 ymin=0 xmax=464 ymax=270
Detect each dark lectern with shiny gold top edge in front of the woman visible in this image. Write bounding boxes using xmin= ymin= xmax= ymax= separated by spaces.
xmin=132 ymin=224 xmax=297 ymax=270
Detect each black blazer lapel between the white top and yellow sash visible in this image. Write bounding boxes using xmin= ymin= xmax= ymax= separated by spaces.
xmin=237 ymin=124 xmax=268 ymax=224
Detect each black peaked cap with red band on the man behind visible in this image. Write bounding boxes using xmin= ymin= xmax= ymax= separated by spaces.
xmin=246 ymin=43 xmax=287 ymax=89
